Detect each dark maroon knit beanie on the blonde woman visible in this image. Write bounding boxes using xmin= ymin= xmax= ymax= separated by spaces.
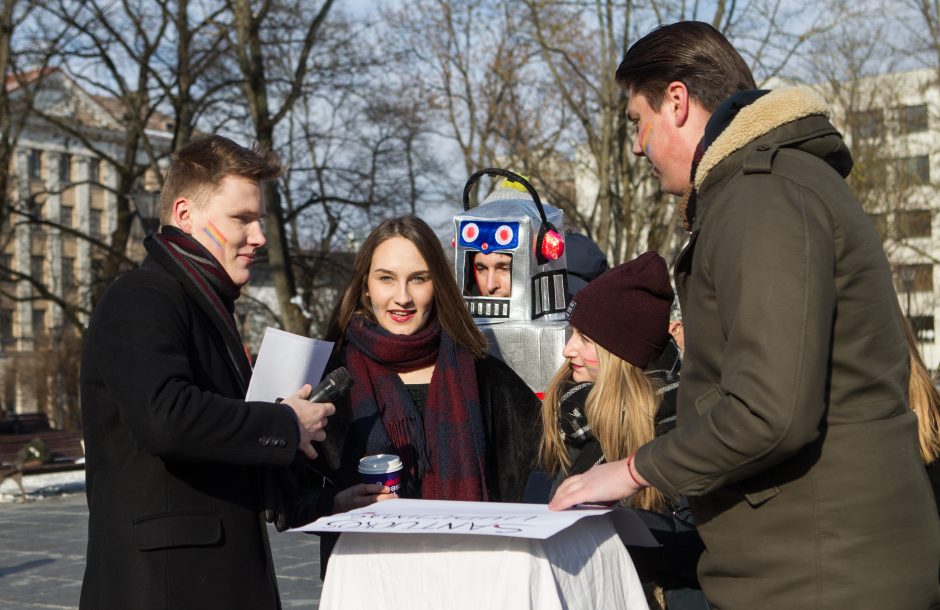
xmin=567 ymin=252 xmax=674 ymax=369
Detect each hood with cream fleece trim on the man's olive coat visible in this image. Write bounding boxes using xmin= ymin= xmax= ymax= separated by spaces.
xmin=680 ymin=87 xmax=851 ymax=228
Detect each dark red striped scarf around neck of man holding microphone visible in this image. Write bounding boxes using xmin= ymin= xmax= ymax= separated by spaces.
xmin=144 ymin=225 xmax=251 ymax=393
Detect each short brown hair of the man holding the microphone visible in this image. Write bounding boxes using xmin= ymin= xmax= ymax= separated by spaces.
xmin=160 ymin=135 xmax=284 ymax=224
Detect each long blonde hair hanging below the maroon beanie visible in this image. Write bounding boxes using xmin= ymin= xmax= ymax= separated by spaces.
xmin=539 ymin=343 xmax=667 ymax=512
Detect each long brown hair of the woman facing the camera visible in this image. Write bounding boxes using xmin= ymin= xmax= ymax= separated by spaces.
xmin=326 ymin=216 xmax=486 ymax=358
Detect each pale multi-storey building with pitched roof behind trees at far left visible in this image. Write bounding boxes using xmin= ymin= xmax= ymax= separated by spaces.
xmin=0 ymin=71 xmax=172 ymax=426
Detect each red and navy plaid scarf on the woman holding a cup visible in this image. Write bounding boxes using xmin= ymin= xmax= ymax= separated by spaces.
xmin=344 ymin=316 xmax=487 ymax=500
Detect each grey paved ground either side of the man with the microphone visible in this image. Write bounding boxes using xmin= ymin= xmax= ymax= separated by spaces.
xmin=0 ymin=487 xmax=321 ymax=610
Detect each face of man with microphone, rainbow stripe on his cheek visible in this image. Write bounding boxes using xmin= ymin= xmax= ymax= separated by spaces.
xmin=187 ymin=176 xmax=266 ymax=286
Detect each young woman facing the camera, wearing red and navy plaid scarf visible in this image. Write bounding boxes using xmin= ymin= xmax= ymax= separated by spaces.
xmin=292 ymin=216 xmax=540 ymax=566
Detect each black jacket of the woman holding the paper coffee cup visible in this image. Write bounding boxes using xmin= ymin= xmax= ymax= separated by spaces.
xmin=289 ymin=356 xmax=541 ymax=576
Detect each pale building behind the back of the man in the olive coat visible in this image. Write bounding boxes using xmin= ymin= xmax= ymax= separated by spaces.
xmin=819 ymin=69 xmax=940 ymax=373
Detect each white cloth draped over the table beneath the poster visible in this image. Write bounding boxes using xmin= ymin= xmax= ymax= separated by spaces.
xmin=320 ymin=515 xmax=648 ymax=610
